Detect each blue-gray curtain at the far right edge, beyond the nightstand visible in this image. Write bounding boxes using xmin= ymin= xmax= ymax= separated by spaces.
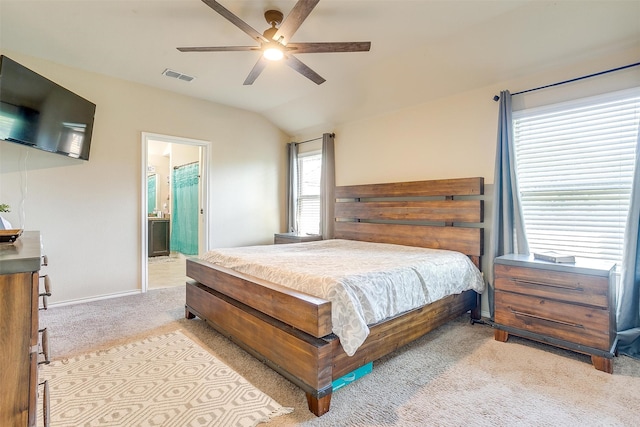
xmin=616 ymin=125 xmax=640 ymax=359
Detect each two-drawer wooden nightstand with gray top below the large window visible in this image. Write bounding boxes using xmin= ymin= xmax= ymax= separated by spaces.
xmin=494 ymin=254 xmax=617 ymax=373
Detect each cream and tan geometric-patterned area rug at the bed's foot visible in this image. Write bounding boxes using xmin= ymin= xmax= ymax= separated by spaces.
xmin=38 ymin=331 xmax=292 ymax=427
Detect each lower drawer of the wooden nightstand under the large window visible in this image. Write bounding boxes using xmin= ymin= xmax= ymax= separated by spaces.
xmin=495 ymin=291 xmax=612 ymax=351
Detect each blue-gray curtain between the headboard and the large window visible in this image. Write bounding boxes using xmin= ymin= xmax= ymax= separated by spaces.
xmin=485 ymin=90 xmax=529 ymax=319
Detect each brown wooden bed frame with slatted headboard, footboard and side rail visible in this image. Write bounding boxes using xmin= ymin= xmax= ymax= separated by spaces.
xmin=185 ymin=178 xmax=484 ymax=416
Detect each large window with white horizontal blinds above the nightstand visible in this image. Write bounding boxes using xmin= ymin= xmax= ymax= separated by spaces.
xmin=513 ymin=90 xmax=640 ymax=264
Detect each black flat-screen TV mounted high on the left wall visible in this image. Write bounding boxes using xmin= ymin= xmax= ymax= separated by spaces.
xmin=0 ymin=55 xmax=96 ymax=160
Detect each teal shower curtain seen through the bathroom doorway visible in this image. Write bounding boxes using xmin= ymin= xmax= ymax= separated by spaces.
xmin=171 ymin=163 xmax=199 ymax=255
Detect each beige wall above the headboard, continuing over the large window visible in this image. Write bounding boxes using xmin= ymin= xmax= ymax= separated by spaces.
xmin=332 ymin=46 xmax=640 ymax=185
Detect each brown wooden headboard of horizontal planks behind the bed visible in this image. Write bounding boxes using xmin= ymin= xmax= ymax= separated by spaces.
xmin=334 ymin=177 xmax=484 ymax=268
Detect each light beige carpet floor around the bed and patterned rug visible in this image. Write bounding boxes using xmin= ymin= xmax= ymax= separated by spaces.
xmin=41 ymin=285 xmax=640 ymax=427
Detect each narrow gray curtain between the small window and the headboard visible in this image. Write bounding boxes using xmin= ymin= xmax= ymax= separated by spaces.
xmin=320 ymin=133 xmax=336 ymax=239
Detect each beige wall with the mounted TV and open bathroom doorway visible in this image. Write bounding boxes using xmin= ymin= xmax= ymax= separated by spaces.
xmin=0 ymin=51 xmax=288 ymax=303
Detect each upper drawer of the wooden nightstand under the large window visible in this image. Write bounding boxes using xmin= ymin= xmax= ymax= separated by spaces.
xmin=495 ymin=264 xmax=609 ymax=309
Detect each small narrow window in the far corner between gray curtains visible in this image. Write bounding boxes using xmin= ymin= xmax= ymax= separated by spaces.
xmin=296 ymin=151 xmax=322 ymax=234
